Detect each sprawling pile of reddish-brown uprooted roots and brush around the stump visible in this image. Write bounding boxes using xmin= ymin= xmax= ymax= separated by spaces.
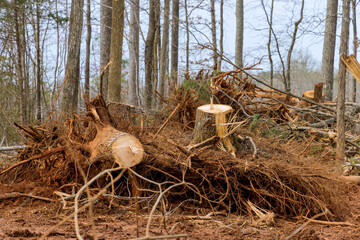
xmin=0 ymin=68 xmax=346 ymax=219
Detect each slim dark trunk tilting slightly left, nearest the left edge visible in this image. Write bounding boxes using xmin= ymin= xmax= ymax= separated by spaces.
xmin=14 ymin=0 xmax=27 ymax=125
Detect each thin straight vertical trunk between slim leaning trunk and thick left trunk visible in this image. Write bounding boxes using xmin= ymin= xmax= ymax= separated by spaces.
xmin=35 ymin=1 xmax=41 ymax=121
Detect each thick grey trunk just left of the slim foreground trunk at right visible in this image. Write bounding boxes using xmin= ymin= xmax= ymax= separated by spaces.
xmin=321 ymin=0 xmax=338 ymax=101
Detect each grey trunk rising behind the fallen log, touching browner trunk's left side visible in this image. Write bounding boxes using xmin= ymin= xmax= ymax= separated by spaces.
xmin=100 ymin=0 xmax=112 ymax=99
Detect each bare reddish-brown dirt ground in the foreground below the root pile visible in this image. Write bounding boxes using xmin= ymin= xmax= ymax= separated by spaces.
xmin=0 ymin=182 xmax=360 ymax=240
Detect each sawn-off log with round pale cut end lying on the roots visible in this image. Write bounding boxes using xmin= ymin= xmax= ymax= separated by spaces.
xmin=87 ymin=95 xmax=144 ymax=168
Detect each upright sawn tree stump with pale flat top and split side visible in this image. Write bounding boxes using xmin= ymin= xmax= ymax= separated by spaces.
xmin=193 ymin=104 xmax=235 ymax=155
